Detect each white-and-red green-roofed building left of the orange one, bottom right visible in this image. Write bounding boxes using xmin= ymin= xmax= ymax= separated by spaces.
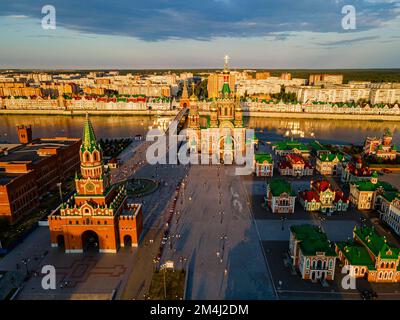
xmin=289 ymin=224 xmax=337 ymax=281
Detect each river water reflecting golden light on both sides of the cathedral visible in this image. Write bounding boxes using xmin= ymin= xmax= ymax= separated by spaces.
xmin=0 ymin=115 xmax=400 ymax=144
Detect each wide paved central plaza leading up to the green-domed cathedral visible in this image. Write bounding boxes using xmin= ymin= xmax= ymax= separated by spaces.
xmin=162 ymin=166 xmax=275 ymax=299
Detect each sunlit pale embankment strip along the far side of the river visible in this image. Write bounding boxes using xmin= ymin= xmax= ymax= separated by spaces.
xmin=0 ymin=109 xmax=400 ymax=121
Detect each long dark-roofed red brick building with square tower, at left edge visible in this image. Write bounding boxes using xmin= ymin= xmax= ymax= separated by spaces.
xmin=0 ymin=126 xmax=81 ymax=223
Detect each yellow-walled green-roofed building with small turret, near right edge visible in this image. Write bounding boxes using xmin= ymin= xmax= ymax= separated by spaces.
xmin=350 ymin=171 xmax=397 ymax=210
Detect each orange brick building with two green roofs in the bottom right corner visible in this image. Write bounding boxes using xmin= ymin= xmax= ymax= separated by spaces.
xmin=336 ymin=227 xmax=400 ymax=282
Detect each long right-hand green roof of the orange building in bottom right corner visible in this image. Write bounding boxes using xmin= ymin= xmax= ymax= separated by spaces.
xmin=354 ymin=227 xmax=400 ymax=260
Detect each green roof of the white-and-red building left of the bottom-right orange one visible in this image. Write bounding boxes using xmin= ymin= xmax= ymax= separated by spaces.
xmin=290 ymin=224 xmax=336 ymax=256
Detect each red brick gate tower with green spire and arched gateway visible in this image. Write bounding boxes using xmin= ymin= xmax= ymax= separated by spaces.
xmin=48 ymin=118 xmax=143 ymax=253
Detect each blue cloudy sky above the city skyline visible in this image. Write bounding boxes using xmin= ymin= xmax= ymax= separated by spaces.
xmin=0 ymin=0 xmax=400 ymax=69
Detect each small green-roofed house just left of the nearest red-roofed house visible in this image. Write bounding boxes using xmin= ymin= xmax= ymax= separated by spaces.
xmin=264 ymin=179 xmax=296 ymax=213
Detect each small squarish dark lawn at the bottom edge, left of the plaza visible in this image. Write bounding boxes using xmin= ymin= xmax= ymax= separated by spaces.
xmin=148 ymin=270 xmax=186 ymax=300
